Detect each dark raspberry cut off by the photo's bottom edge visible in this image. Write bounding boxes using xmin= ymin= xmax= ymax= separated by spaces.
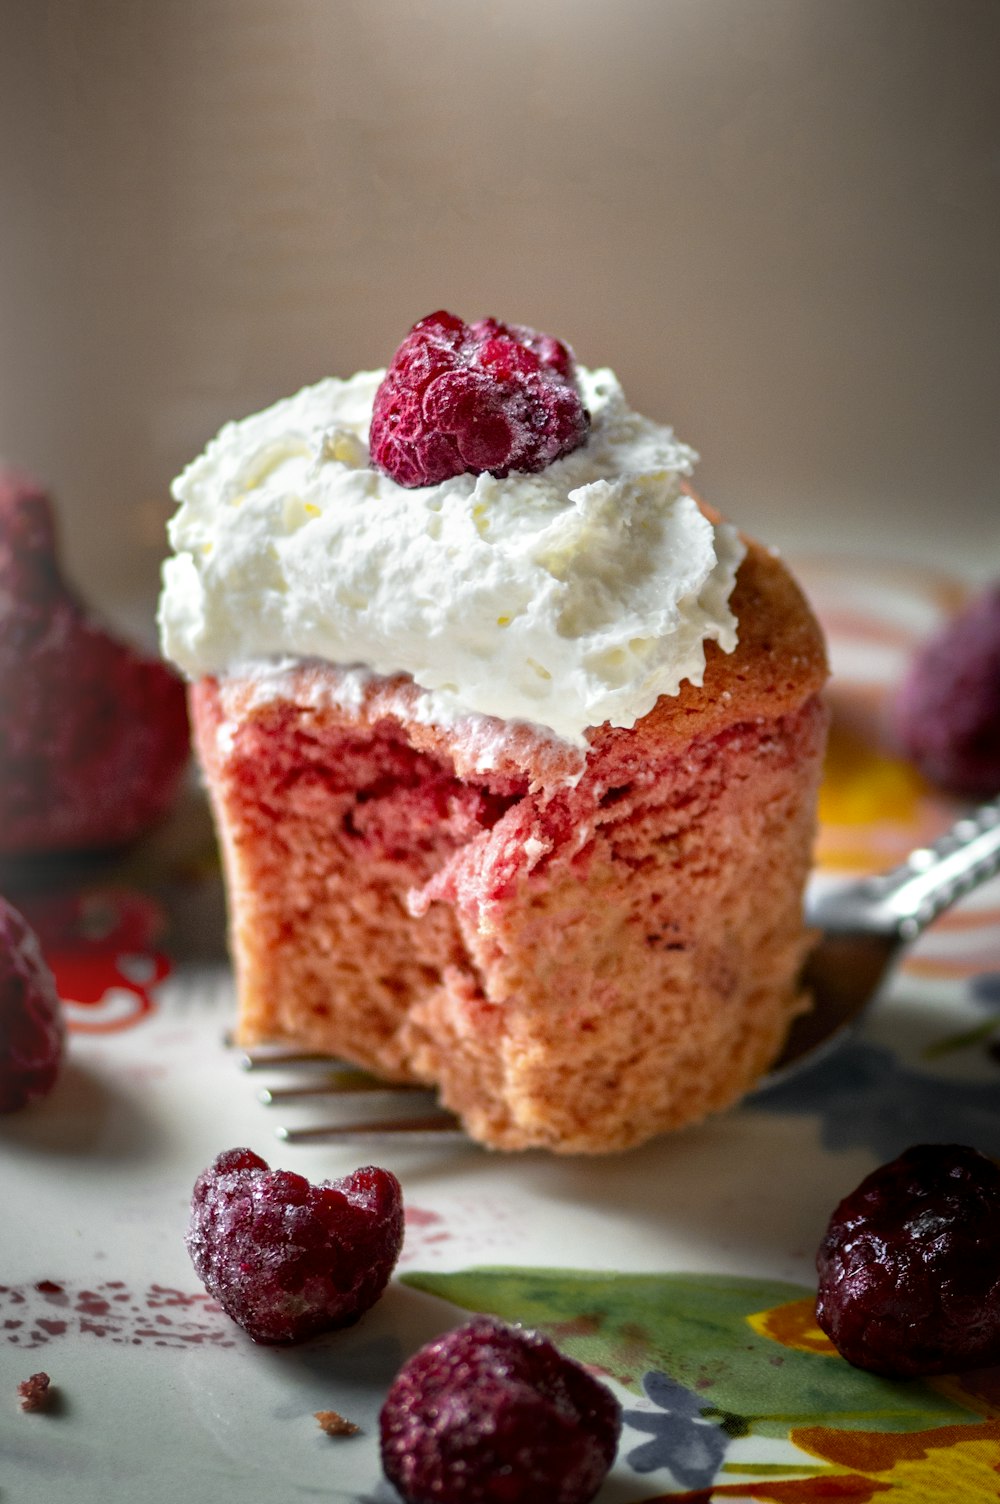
xmin=380 ymin=1316 xmax=621 ymax=1504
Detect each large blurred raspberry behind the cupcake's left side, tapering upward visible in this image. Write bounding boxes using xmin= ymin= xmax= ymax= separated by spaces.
xmin=0 ymin=471 xmax=189 ymax=856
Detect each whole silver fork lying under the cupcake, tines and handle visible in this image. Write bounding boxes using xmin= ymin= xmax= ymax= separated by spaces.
xmin=242 ymin=800 xmax=1000 ymax=1143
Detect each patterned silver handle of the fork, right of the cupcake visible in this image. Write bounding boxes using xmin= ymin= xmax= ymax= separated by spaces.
xmin=811 ymin=800 xmax=1000 ymax=942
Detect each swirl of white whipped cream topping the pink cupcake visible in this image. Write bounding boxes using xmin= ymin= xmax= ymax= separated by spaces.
xmin=159 ymin=370 xmax=744 ymax=746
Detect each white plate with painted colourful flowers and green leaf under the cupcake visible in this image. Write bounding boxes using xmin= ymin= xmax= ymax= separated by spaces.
xmin=0 ymin=561 xmax=1000 ymax=1504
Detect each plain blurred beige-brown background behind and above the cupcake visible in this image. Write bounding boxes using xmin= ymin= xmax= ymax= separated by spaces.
xmin=0 ymin=0 xmax=1000 ymax=621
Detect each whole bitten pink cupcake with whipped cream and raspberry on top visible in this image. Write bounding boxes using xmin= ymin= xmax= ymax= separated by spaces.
xmin=161 ymin=313 xmax=826 ymax=1152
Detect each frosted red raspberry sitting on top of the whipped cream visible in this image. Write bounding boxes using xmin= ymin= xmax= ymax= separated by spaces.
xmin=370 ymin=311 xmax=589 ymax=486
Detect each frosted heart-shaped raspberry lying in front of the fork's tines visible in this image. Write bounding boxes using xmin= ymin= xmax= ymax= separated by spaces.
xmin=186 ymin=1149 xmax=403 ymax=1342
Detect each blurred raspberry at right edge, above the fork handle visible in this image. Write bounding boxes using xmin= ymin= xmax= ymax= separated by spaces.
xmin=893 ymin=584 xmax=1000 ymax=799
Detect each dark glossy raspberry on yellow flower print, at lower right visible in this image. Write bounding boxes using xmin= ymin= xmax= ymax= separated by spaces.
xmin=817 ymin=1143 xmax=1000 ymax=1378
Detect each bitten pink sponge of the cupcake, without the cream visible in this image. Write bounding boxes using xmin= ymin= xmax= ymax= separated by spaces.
xmin=191 ymin=543 xmax=827 ymax=1154
